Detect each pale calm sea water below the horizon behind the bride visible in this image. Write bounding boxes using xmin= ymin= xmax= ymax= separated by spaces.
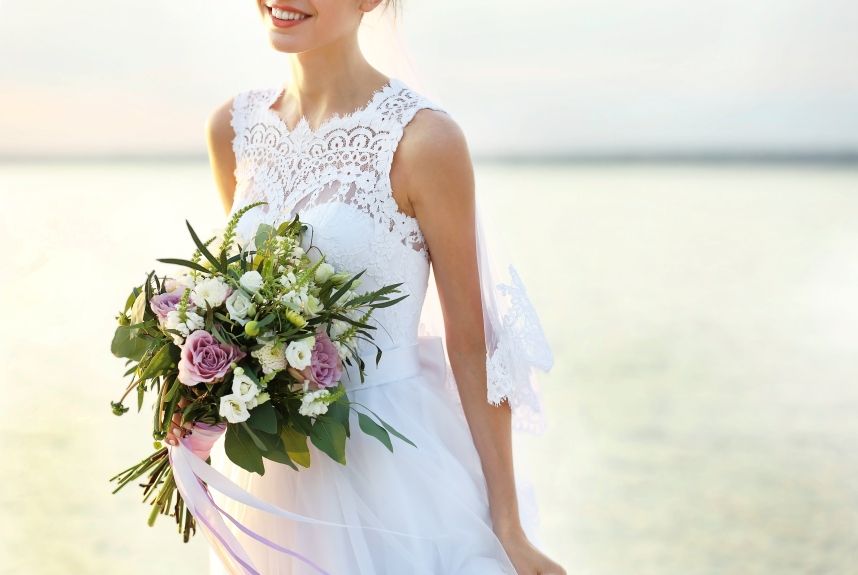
xmin=0 ymin=161 xmax=858 ymax=575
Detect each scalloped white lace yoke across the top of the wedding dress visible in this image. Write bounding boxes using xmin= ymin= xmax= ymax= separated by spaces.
xmin=227 ymin=78 xmax=444 ymax=260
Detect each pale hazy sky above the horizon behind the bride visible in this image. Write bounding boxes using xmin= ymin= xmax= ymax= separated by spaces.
xmin=0 ymin=0 xmax=858 ymax=156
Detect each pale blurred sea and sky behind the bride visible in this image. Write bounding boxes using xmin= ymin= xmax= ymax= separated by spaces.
xmin=0 ymin=0 xmax=858 ymax=575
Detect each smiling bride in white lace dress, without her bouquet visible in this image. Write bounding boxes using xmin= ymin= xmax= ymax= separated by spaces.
xmin=168 ymin=0 xmax=565 ymax=575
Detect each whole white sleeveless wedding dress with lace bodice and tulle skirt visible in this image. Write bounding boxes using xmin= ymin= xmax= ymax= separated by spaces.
xmin=210 ymin=77 xmax=538 ymax=575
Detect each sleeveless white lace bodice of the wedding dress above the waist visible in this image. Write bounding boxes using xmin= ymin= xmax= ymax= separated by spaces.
xmin=224 ymin=77 xmax=444 ymax=353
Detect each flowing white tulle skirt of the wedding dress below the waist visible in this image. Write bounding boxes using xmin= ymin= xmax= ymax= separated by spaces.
xmin=209 ymin=336 xmax=538 ymax=575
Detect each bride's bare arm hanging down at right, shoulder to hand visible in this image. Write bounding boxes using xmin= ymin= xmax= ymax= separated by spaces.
xmin=391 ymin=110 xmax=564 ymax=575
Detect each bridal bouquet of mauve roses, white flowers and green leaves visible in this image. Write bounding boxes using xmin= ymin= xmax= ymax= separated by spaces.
xmin=111 ymin=202 xmax=414 ymax=542
